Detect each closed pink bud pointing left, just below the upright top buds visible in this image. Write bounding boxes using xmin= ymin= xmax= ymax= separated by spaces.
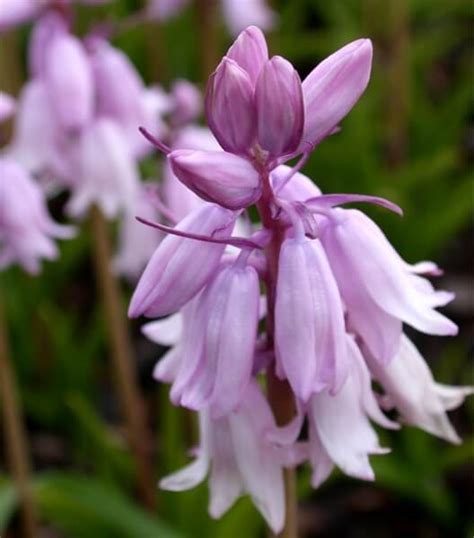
xmin=168 ymin=149 xmax=262 ymax=209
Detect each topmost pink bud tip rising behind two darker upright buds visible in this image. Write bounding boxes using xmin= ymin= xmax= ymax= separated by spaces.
xmin=226 ymin=26 xmax=268 ymax=87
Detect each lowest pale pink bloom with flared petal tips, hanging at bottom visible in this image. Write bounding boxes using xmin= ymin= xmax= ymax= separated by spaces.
xmin=160 ymin=382 xmax=287 ymax=533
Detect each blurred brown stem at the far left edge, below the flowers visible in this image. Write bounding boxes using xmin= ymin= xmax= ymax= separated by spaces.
xmin=0 ymin=297 xmax=38 ymax=538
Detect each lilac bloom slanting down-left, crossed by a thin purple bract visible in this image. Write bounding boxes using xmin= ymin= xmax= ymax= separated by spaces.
xmin=129 ymin=204 xmax=236 ymax=317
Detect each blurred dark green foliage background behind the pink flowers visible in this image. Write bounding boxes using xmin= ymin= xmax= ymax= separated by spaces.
xmin=0 ymin=0 xmax=474 ymax=538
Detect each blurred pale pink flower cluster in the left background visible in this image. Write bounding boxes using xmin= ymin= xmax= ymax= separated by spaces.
xmin=0 ymin=4 xmax=201 ymax=279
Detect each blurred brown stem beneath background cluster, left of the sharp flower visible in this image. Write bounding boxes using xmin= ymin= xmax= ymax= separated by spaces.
xmin=91 ymin=206 xmax=156 ymax=511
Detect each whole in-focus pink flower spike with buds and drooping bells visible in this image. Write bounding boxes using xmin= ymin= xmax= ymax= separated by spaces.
xmin=129 ymin=27 xmax=471 ymax=532
